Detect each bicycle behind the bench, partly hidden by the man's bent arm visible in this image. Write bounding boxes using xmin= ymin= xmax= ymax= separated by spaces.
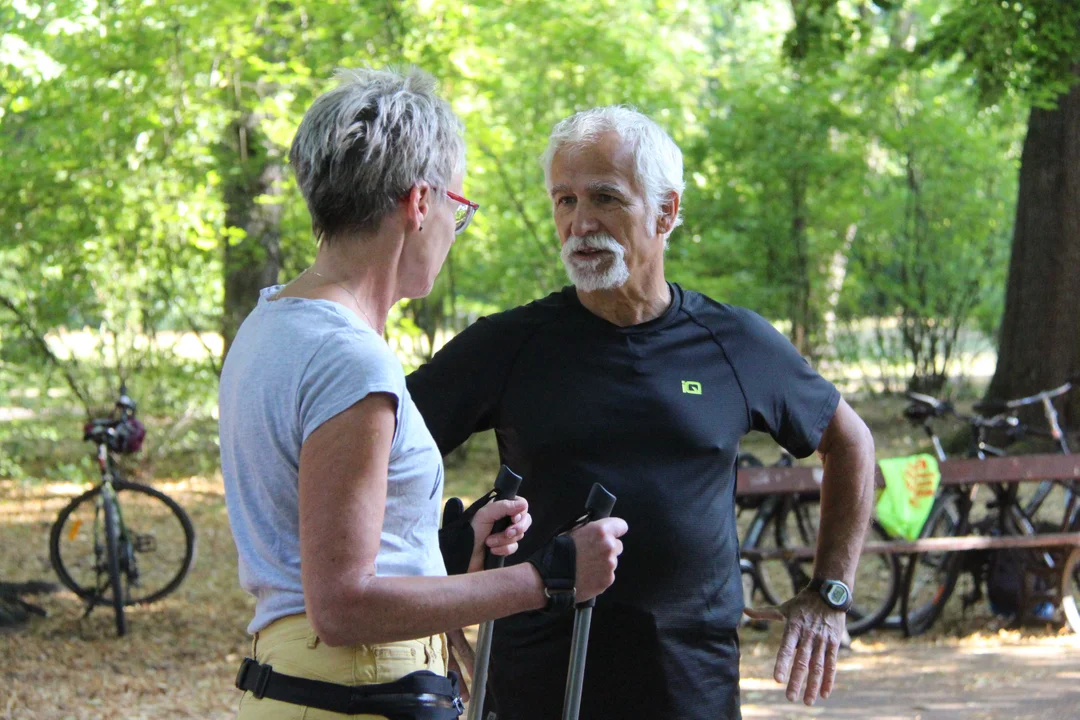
xmin=737 ymin=452 xmax=901 ymax=637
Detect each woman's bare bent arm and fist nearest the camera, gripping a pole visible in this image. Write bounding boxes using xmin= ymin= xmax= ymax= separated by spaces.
xmin=300 ymin=393 xmax=626 ymax=646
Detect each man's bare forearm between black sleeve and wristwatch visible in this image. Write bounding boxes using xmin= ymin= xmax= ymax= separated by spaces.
xmin=814 ymin=421 xmax=875 ymax=587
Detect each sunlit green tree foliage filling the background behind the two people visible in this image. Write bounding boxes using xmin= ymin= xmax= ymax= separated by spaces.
xmin=0 ymin=0 xmax=1054 ymax=431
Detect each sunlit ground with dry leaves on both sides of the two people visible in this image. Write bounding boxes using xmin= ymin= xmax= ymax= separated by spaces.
xmin=0 ymin=470 xmax=1080 ymax=720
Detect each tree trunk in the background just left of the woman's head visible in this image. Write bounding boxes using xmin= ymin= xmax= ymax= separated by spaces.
xmin=221 ymin=116 xmax=285 ymax=357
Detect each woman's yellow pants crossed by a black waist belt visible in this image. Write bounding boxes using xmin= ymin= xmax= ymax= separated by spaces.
xmin=238 ymin=615 xmax=447 ymax=720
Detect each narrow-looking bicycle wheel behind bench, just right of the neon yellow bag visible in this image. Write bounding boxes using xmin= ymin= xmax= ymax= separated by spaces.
xmin=900 ymin=493 xmax=961 ymax=637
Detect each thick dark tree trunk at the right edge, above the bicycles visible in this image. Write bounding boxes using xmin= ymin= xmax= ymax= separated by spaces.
xmin=986 ymin=67 xmax=1080 ymax=426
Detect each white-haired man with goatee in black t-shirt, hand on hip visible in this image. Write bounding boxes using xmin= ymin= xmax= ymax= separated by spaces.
xmin=408 ymin=107 xmax=874 ymax=720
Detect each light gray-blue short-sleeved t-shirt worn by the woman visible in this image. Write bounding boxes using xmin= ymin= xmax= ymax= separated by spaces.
xmin=218 ymin=286 xmax=446 ymax=633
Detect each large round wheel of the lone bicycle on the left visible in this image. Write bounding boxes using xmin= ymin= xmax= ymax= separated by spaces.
xmin=49 ymin=480 xmax=195 ymax=604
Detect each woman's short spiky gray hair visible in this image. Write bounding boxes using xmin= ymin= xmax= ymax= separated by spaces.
xmin=288 ymin=68 xmax=465 ymax=242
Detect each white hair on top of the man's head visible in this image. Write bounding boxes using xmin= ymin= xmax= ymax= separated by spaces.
xmin=540 ymin=105 xmax=686 ymax=229
